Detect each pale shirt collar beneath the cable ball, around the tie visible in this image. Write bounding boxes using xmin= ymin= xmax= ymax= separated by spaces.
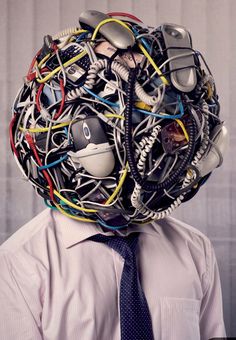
xmin=52 ymin=211 xmax=160 ymax=248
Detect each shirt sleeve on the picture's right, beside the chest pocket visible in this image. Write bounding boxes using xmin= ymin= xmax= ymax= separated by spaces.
xmin=200 ymin=241 xmax=226 ymax=340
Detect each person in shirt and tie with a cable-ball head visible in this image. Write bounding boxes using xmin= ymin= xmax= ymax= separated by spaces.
xmin=0 ymin=11 xmax=226 ymax=340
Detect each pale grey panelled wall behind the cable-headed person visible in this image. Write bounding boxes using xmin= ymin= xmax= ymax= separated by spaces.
xmin=0 ymin=0 xmax=236 ymax=336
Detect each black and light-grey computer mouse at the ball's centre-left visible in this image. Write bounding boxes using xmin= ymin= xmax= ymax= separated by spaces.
xmin=68 ymin=116 xmax=115 ymax=177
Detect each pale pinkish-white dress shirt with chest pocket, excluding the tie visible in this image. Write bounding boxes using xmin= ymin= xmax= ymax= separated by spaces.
xmin=0 ymin=209 xmax=225 ymax=340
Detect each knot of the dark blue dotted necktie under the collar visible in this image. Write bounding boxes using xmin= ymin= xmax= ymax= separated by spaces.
xmin=89 ymin=233 xmax=139 ymax=259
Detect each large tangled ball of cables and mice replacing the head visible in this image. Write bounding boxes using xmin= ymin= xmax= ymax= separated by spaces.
xmin=10 ymin=13 xmax=225 ymax=229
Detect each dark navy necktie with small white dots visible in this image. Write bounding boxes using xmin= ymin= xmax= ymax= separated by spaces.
xmin=90 ymin=233 xmax=154 ymax=340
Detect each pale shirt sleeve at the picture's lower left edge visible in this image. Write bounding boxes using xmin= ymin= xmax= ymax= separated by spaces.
xmin=0 ymin=252 xmax=42 ymax=340
